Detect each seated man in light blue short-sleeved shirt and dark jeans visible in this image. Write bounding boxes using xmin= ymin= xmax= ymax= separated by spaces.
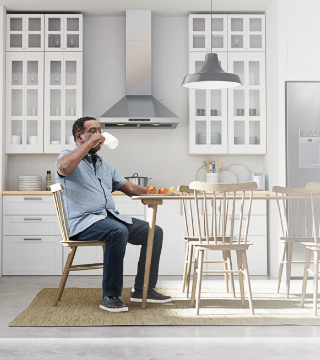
xmin=56 ymin=117 xmax=171 ymax=312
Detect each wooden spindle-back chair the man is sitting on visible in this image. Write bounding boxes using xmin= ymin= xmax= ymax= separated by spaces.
xmin=50 ymin=184 xmax=105 ymax=306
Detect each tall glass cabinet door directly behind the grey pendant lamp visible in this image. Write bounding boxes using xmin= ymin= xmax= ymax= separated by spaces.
xmin=189 ymin=52 xmax=228 ymax=154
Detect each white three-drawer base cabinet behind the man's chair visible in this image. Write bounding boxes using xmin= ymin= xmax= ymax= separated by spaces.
xmin=2 ymin=195 xmax=62 ymax=275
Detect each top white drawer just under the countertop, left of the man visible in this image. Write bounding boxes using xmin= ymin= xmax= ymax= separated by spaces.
xmin=3 ymin=195 xmax=56 ymax=216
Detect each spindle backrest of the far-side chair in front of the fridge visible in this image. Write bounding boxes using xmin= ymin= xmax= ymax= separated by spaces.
xmin=272 ymin=186 xmax=320 ymax=243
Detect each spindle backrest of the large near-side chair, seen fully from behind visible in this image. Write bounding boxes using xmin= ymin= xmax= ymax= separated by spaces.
xmin=189 ymin=181 xmax=257 ymax=244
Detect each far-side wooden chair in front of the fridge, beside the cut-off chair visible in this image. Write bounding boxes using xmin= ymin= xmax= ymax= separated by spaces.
xmin=272 ymin=186 xmax=314 ymax=299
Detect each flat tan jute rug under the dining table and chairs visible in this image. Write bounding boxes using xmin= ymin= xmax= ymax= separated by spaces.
xmin=9 ymin=287 xmax=320 ymax=326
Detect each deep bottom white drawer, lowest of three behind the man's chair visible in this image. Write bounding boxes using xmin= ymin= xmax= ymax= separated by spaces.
xmin=3 ymin=236 xmax=62 ymax=275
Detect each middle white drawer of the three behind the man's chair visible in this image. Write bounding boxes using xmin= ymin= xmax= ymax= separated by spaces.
xmin=3 ymin=215 xmax=61 ymax=238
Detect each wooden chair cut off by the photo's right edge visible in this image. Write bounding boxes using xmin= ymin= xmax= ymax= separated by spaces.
xmin=301 ymin=182 xmax=320 ymax=316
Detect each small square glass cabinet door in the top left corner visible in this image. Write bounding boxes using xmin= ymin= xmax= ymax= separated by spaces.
xmin=6 ymin=14 xmax=44 ymax=51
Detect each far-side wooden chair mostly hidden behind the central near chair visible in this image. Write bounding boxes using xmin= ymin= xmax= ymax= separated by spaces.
xmin=178 ymin=185 xmax=235 ymax=298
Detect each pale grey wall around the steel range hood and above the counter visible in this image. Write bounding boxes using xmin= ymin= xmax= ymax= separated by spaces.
xmin=8 ymin=17 xmax=263 ymax=190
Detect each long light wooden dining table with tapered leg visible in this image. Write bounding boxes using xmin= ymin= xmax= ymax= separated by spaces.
xmin=132 ymin=191 xmax=320 ymax=309
